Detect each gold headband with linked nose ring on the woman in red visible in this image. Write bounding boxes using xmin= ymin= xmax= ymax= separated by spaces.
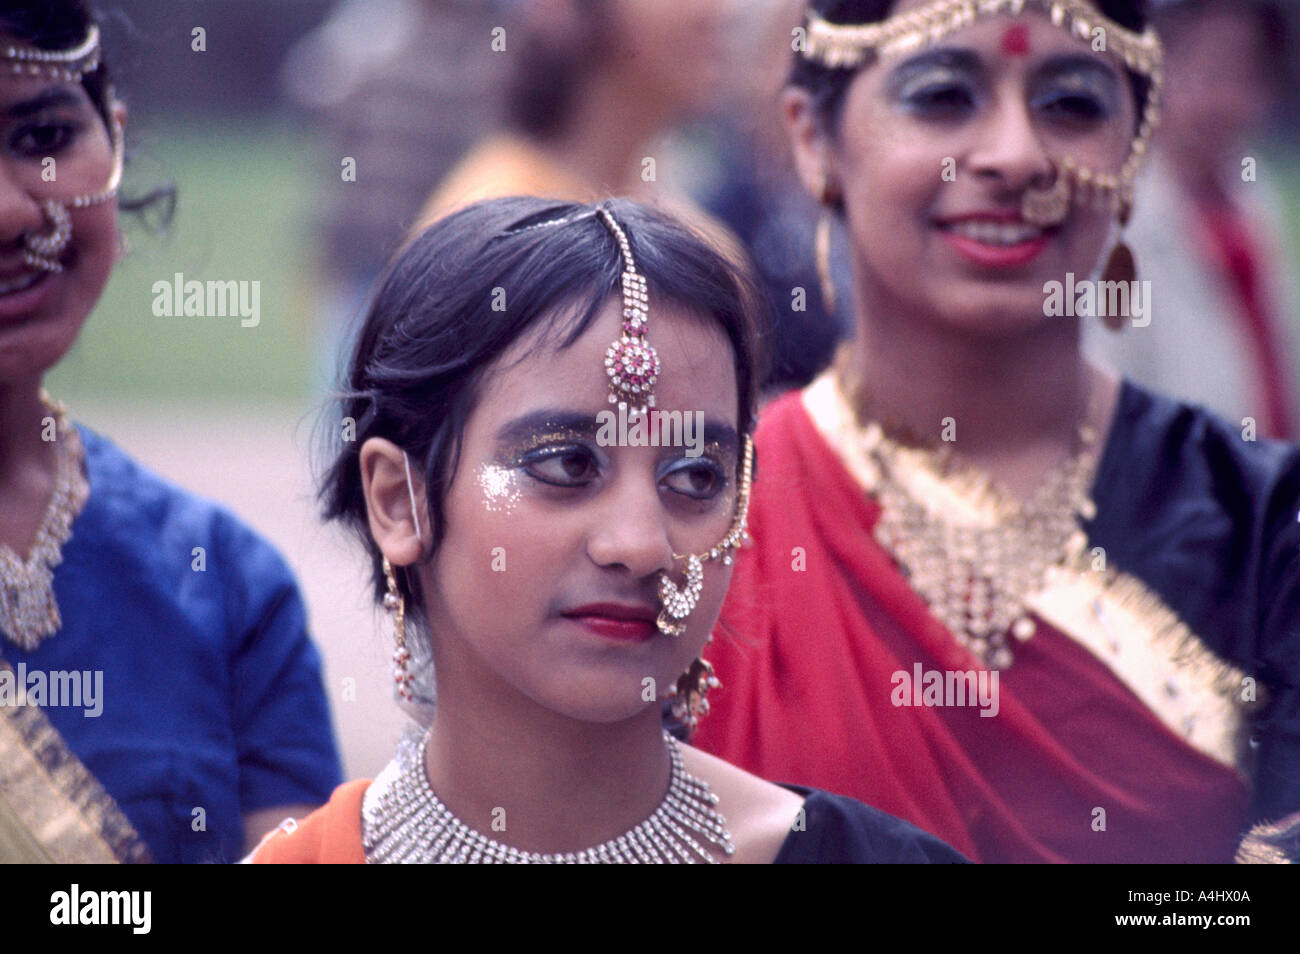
xmin=802 ymin=0 xmax=1165 ymax=226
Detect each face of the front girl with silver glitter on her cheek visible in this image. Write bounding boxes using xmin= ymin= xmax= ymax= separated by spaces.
xmin=420 ymin=299 xmax=740 ymax=721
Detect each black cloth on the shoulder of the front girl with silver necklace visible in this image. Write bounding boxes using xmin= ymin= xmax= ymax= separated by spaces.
xmin=772 ymin=785 xmax=970 ymax=864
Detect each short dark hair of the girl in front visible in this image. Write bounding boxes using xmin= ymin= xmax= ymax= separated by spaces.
xmin=320 ymin=198 xmax=766 ymax=619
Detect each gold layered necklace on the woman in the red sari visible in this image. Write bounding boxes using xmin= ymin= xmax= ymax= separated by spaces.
xmin=833 ymin=369 xmax=1099 ymax=669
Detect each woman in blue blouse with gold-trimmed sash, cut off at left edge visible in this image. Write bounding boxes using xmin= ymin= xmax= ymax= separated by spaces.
xmin=0 ymin=0 xmax=338 ymax=862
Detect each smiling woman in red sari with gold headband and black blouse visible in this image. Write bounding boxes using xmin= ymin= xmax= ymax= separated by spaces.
xmin=698 ymin=0 xmax=1300 ymax=862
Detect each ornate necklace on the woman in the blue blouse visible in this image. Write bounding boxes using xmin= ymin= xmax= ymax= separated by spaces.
xmin=0 ymin=390 xmax=90 ymax=652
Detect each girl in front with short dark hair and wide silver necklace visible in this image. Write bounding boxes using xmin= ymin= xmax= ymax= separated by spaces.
xmin=254 ymin=199 xmax=961 ymax=863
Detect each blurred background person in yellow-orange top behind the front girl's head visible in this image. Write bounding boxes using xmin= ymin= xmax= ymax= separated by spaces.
xmin=413 ymin=0 xmax=744 ymax=260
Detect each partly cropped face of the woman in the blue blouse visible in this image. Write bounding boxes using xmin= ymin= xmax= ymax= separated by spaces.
xmin=0 ymin=56 xmax=118 ymax=386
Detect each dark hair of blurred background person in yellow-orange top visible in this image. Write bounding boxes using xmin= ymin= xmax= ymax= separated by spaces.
xmin=506 ymin=0 xmax=612 ymax=138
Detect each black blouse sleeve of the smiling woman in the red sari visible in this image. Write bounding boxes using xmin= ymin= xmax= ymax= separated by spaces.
xmin=1084 ymin=380 xmax=1300 ymax=821
